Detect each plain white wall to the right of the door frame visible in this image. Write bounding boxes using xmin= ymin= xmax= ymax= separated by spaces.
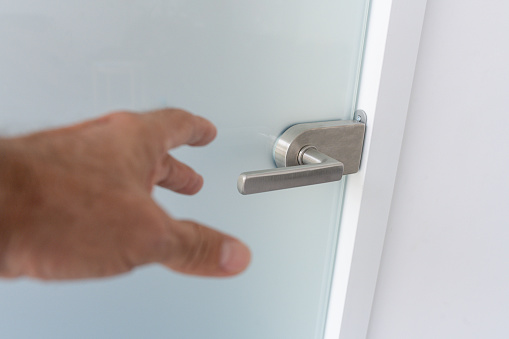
xmin=368 ymin=0 xmax=509 ymax=339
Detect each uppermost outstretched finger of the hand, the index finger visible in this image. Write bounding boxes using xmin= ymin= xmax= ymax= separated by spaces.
xmin=142 ymin=108 xmax=217 ymax=150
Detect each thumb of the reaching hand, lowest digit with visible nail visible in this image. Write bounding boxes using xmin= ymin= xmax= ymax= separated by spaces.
xmin=162 ymin=218 xmax=251 ymax=277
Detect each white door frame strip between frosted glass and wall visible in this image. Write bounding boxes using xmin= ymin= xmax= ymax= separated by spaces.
xmin=325 ymin=0 xmax=427 ymax=339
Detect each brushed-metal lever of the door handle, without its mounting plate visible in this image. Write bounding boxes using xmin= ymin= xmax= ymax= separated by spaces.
xmin=237 ymin=146 xmax=344 ymax=194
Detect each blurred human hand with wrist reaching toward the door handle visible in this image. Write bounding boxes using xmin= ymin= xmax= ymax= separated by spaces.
xmin=0 ymin=109 xmax=250 ymax=280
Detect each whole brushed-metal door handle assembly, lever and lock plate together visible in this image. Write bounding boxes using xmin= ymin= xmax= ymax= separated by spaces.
xmin=237 ymin=111 xmax=366 ymax=194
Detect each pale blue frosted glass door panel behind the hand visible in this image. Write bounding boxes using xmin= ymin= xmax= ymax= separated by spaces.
xmin=0 ymin=0 xmax=369 ymax=339
